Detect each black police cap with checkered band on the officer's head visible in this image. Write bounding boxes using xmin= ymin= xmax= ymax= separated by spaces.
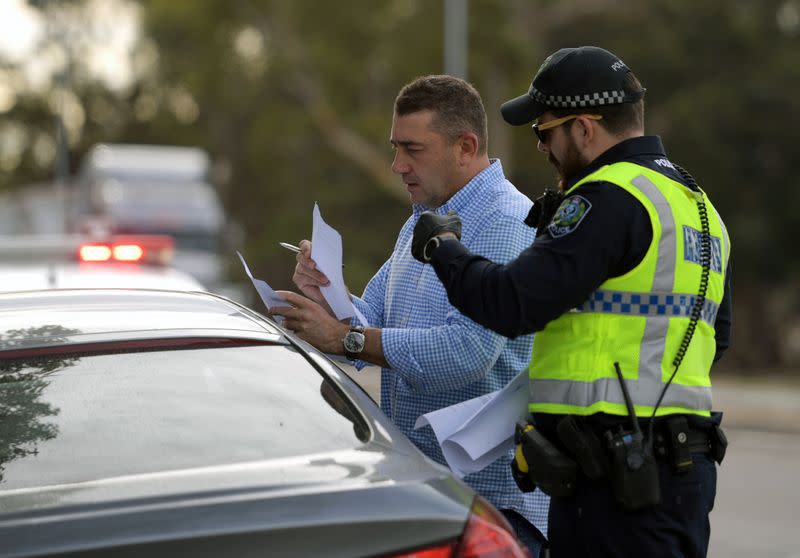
xmin=500 ymin=46 xmax=645 ymax=126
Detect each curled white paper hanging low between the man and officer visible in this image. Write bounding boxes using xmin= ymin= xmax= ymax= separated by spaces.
xmin=414 ymin=370 xmax=528 ymax=477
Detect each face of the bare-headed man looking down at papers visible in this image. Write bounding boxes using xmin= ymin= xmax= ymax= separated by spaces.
xmin=390 ymin=110 xmax=463 ymax=208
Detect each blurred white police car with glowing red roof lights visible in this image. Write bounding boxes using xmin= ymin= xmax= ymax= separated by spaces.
xmin=0 ymin=235 xmax=205 ymax=292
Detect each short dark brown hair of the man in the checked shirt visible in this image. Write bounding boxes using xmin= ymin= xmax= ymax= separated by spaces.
xmin=394 ymin=75 xmax=488 ymax=154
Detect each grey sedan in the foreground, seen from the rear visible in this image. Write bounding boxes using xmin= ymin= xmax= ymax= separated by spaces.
xmin=0 ymin=289 xmax=526 ymax=558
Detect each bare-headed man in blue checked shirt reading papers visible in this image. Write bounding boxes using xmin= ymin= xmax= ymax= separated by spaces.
xmin=274 ymin=76 xmax=549 ymax=557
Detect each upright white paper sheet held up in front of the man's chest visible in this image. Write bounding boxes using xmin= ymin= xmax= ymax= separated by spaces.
xmin=311 ymin=203 xmax=368 ymax=326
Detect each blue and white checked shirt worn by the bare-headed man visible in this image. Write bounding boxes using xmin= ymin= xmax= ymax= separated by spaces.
xmin=353 ymin=160 xmax=549 ymax=536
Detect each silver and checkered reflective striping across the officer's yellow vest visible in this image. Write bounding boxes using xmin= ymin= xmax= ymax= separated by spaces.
xmin=528 ymin=175 xmax=718 ymax=411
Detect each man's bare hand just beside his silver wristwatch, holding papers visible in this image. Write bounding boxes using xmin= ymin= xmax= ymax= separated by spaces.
xmin=270 ymin=294 xmax=350 ymax=355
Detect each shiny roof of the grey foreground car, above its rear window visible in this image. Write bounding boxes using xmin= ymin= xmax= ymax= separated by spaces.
xmin=0 ymin=289 xmax=283 ymax=351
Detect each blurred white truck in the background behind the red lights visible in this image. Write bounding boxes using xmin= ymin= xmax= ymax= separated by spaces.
xmin=67 ymin=144 xmax=229 ymax=290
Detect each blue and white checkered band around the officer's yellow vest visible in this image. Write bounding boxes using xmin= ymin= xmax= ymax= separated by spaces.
xmin=572 ymin=289 xmax=719 ymax=327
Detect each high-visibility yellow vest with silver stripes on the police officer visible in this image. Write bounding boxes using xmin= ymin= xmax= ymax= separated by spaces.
xmin=528 ymin=162 xmax=730 ymax=417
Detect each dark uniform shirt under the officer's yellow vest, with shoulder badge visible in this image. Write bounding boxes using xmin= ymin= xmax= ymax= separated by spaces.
xmin=431 ymin=136 xmax=731 ymax=360
